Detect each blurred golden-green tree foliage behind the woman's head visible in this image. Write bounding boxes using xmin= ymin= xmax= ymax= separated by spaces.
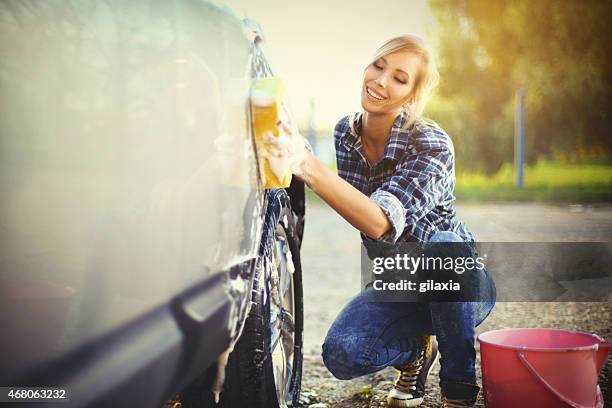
xmin=429 ymin=0 xmax=612 ymax=171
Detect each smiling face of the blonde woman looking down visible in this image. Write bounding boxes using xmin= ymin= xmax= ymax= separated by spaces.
xmin=361 ymin=50 xmax=422 ymax=115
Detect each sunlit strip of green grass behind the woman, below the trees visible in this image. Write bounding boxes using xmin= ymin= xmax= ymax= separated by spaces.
xmin=306 ymin=160 xmax=612 ymax=203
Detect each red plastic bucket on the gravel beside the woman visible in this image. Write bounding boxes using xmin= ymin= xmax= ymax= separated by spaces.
xmin=478 ymin=329 xmax=612 ymax=408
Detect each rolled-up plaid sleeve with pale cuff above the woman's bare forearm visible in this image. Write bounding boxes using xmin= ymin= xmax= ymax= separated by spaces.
xmin=370 ymin=149 xmax=452 ymax=243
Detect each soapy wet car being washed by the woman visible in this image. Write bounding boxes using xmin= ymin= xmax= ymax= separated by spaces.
xmin=0 ymin=0 xmax=305 ymax=408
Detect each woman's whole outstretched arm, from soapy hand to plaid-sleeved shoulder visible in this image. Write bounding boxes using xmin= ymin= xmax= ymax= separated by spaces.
xmin=278 ymin=111 xmax=454 ymax=243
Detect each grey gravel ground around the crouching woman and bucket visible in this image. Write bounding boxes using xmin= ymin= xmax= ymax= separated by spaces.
xmin=301 ymin=202 xmax=612 ymax=408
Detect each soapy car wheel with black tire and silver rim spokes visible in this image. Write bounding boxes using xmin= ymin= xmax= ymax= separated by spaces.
xmin=181 ymin=189 xmax=303 ymax=408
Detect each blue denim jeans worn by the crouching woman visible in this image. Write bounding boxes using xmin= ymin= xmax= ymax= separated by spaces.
xmin=322 ymin=231 xmax=495 ymax=391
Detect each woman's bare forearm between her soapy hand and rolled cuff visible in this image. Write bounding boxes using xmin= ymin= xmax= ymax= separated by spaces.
xmin=299 ymin=153 xmax=392 ymax=239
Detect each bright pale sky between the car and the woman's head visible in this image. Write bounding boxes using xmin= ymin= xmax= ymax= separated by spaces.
xmin=218 ymin=0 xmax=435 ymax=131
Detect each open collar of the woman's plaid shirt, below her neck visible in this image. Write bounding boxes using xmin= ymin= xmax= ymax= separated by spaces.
xmin=344 ymin=110 xmax=412 ymax=165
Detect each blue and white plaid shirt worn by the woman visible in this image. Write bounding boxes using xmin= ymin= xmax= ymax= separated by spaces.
xmin=334 ymin=112 xmax=474 ymax=244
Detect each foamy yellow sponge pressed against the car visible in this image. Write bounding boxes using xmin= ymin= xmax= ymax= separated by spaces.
xmin=251 ymin=77 xmax=291 ymax=188
